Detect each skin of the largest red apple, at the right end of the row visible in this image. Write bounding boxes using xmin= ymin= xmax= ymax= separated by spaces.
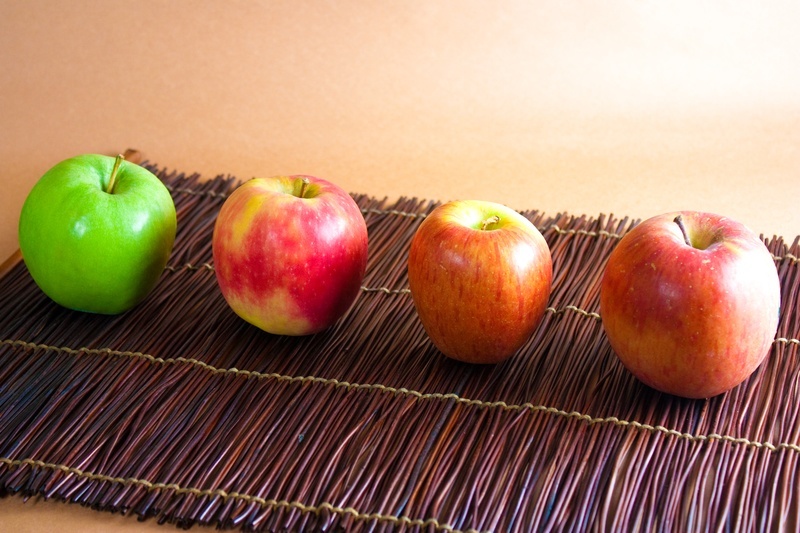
xmin=600 ymin=211 xmax=781 ymax=398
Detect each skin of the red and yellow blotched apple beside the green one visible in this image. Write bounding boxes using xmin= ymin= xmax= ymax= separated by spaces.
xmin=212 ymin=176 xmax=368 ymax=335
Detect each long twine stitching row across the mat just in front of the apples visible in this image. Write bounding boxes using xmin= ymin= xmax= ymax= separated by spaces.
xmin=0 ymin=337 xmax=800 ymax=453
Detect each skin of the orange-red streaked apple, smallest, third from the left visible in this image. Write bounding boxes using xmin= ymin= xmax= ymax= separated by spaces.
xmin=408 ymin=200 xmax=553 ymax=364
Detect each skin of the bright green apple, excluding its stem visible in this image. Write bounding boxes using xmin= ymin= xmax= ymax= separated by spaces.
xmin=18 ymin=154 xmax=177 ymax=314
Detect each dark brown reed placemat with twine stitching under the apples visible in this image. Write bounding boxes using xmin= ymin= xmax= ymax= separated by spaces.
xmin=0 ymin=165 xmax=800 ymax=532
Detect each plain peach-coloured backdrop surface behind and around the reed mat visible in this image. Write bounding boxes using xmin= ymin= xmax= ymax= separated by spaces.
xmin=0 ymin=0 xmax=800 ymax=531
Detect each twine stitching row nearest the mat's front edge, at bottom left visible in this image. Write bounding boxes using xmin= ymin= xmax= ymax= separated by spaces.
xmin=0 ymin=457 xmax=477 ymax=533
